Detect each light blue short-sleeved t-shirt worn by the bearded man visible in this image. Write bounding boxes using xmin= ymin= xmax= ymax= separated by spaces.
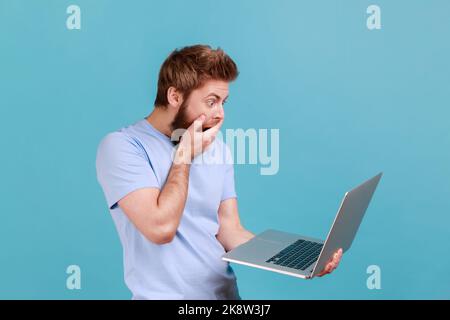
xmin=96 ymin=119 xmax=240 ymax=299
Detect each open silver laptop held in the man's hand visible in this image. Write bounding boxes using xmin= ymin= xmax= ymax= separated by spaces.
xmin=222 ymin=173 xmax=382 ymax=279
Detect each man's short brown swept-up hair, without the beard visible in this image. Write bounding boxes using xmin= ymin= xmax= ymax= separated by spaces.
xmin=155 ymin=45 xmax=239 ymax=107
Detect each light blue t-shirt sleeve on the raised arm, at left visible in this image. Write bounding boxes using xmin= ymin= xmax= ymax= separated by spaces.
xmin=96 ymin=132 xmax=160 ymax=209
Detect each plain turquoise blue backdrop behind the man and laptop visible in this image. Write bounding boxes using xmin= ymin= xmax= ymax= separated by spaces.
xmin=0 ymin=0 xmax=450 ymax=299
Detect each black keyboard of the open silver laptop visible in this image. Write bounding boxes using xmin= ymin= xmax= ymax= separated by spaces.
xmin=266 ymin=240 xmax=323 ymax=270
